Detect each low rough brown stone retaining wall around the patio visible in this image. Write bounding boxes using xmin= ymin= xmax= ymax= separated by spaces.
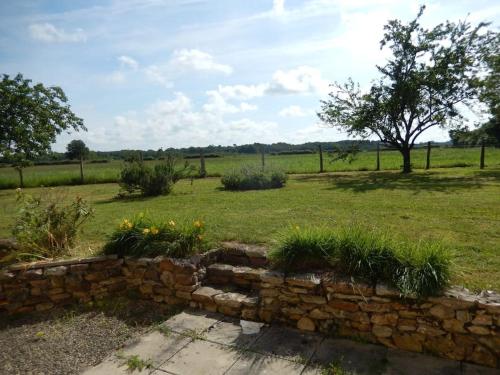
xmin=0 ymin=252 xmax=500 ymax=367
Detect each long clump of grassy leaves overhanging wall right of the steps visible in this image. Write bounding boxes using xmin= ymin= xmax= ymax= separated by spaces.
xmin=269 ymin=227 xmax=450 ymax=296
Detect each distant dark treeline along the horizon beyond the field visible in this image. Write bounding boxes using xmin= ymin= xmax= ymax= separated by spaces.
xmin=0 ymin=140 xmax=451 ymax=165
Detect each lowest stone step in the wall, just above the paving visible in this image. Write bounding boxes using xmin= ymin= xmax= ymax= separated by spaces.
xmin=191 ymin=284 xmax=259 ymax=320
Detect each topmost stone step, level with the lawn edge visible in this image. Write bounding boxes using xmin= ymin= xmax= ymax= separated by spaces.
xmin=219 ymin=241 xmax=269 ymax=267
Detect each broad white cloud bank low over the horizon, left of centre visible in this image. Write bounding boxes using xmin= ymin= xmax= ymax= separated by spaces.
xmin=106 ymin=91 xmax=279 ymax=148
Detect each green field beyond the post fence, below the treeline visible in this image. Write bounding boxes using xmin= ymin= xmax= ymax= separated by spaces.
xmin=0 ymin=148 xmax=500 ymax=189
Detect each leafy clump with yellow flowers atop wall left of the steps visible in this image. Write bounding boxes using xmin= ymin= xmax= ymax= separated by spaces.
xmin=103 ymin=215 xmax=204 ymax=258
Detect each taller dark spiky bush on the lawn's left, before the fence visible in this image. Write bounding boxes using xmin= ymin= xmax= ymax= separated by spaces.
xmin=120 ymin=156 xmax=191 ymax=196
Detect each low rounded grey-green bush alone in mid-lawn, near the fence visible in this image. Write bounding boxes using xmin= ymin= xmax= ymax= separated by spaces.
xmin=221 ymin=166 xmax=288 ymax=190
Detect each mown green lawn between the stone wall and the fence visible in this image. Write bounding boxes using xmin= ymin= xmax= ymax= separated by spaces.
xmin=0 ymin=167 xmax=500 ymax=290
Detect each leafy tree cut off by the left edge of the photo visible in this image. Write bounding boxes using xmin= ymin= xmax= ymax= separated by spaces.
xmin=0 ymin=74 xmax=86 ymax=187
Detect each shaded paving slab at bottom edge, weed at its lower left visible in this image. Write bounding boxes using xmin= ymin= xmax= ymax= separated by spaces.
xmin=307 ymin=338 xmax=387 ymax=375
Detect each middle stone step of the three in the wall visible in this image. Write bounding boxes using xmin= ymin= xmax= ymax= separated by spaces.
xmin=207 ymin=263 xmax=267 ymax=289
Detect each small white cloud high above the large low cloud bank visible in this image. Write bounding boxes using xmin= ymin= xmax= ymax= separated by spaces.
xmin=170 ymin=49 xmax=233 ymax=74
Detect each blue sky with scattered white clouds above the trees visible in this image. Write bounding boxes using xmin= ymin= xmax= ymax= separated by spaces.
xmin=0 ymin=0 xmax=500 ymax=151
